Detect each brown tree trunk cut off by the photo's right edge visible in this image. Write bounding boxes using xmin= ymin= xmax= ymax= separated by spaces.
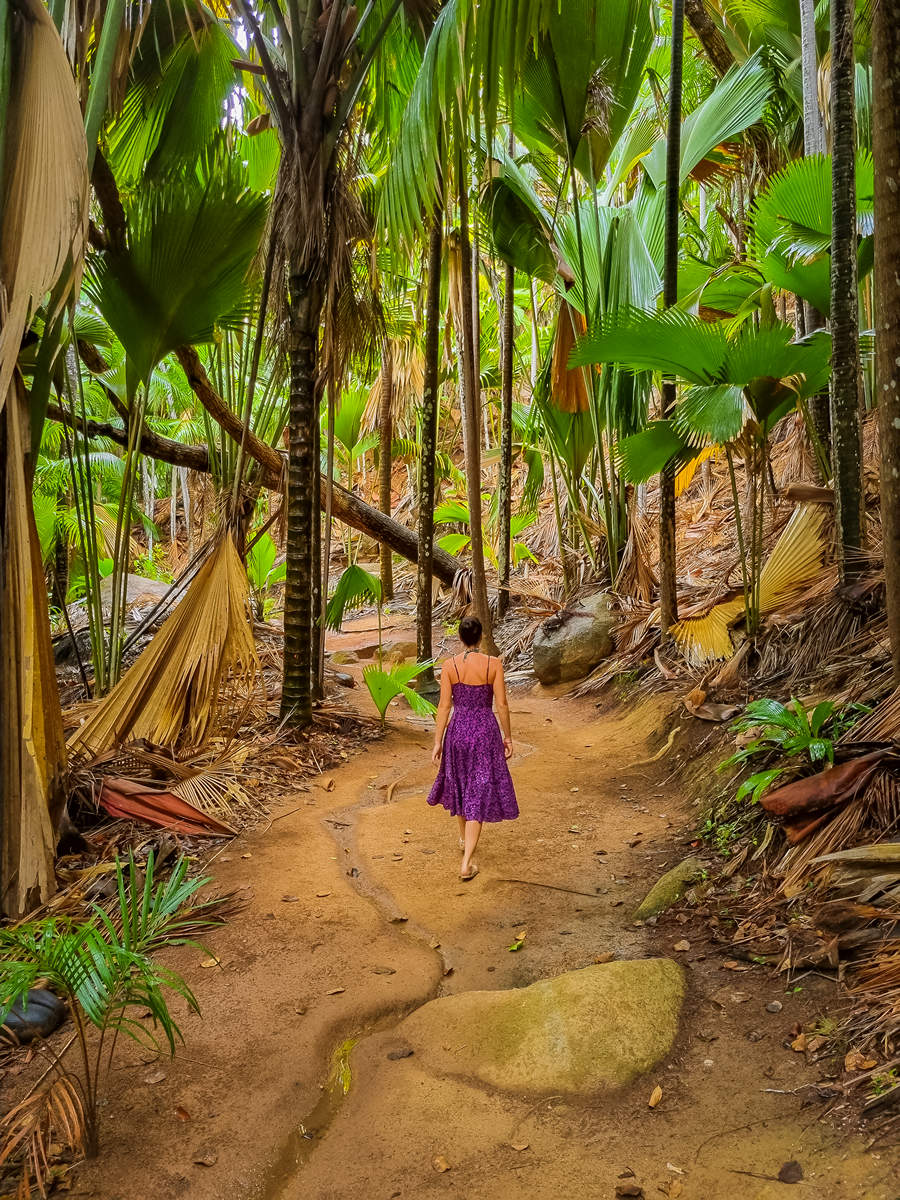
xmin=872 ymin=0 xmax=900 ymax=686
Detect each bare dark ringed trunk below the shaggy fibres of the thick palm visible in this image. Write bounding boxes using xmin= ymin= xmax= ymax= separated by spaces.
xmin=281 ymin=270 xmax=323 ymax=728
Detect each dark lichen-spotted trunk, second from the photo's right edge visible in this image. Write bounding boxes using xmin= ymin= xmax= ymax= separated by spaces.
xmin=830 ymin=0 xmax=865 ymax=581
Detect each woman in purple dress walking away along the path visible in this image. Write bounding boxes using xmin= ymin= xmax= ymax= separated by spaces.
xmin=428 ymin=617 xmax=518 ymax=882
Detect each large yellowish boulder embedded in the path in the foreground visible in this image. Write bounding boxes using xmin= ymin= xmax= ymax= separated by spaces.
xmin=397 ymin=959 xmax=684 ymax=1097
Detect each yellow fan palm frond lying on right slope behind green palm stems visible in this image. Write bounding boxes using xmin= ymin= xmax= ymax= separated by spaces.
xmin=670 ymin=506 xmax=824 ymax=665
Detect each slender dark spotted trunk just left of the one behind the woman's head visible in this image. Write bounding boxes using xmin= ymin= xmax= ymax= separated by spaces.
xmin=415 ymin=205 xmax=444 ymax=688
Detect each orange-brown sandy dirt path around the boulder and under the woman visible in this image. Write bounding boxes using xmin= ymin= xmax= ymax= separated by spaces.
xmin=70 ymin=622 xmax=900 ymax=1200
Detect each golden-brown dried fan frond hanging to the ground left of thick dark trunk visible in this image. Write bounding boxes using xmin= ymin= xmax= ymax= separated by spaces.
xmin=68 ymin=535 xmax=259 ymax=755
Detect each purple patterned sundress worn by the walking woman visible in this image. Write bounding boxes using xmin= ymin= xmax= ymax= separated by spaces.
xmin=428 ymin=683 xmax=518 ymax=821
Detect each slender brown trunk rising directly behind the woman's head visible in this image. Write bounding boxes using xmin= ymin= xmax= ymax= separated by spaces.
xmin=460 ymin=170 xmax=497 ymax=654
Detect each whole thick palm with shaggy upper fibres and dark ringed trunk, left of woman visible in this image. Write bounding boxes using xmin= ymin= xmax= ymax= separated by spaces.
xmin=235 ymin=0 xmax=427 ymax=728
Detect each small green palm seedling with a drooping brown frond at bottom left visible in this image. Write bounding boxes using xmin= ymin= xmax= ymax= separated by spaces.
xmin=0 ymin=853 xmax=223 ymax=1195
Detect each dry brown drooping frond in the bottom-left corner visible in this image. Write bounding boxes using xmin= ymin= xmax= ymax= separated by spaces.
xmin=0 ymin=1072 xmax=88 ymax=1196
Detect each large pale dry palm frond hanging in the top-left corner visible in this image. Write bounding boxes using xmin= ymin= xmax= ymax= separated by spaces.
xmin=0 ymin=0 xmax=88 ymax=409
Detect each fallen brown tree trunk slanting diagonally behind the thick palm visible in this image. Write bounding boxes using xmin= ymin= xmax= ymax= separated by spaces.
xmin=47 ymin=393 xmax=466 ymax=588
